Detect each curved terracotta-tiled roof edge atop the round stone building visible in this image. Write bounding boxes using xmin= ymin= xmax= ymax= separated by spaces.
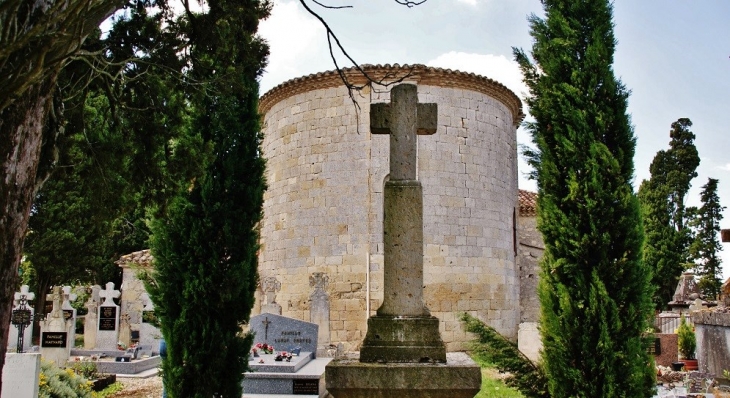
xmin=259 ymin=64 xmax=525 ymax=126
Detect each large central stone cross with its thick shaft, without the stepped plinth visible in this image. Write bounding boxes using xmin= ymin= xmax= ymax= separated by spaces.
xmin=370 ymin=84 xmax=438 ymax=316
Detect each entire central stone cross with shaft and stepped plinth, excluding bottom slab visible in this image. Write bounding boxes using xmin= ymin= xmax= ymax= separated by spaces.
xmin=360 ymin=84 xmax=446 ymax=363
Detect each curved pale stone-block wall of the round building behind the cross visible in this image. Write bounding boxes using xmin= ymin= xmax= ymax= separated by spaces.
xmin=259 ymin=68 xmax=521 ymax=351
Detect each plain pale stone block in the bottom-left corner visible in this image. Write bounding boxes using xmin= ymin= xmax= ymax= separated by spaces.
xmin=0 ymin=353 xmax=41 ymax=398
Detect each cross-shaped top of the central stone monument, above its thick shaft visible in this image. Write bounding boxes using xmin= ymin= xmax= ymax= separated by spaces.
xmin=370 ymin=84 xmax=438 ymax=180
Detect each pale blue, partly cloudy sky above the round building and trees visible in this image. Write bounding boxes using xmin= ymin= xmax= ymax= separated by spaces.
xmin=253 ymin=0 xmax=730 ymax=277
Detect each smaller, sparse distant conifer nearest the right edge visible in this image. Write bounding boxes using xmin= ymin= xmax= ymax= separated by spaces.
xmin=689 ymin=178 xmax=725 ymax=299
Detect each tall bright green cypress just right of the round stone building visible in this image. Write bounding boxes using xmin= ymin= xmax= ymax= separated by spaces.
xmin=515 ymin=0 xmax=654 ymax=398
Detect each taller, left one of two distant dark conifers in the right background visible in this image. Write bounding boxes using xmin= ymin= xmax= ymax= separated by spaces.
xmin=639 ymin=118 xmax=700 ymax=308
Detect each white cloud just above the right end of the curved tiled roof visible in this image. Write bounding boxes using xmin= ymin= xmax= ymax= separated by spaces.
xmin=427 ymin=51 xmax=527 ymax=98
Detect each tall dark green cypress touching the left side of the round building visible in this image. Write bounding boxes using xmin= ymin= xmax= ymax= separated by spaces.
xmin=147 ymin=0 xmax=269 ymax=398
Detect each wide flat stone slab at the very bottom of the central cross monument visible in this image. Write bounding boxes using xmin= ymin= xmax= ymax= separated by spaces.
xmin=325 ymin=352 xmax=482 ymax=398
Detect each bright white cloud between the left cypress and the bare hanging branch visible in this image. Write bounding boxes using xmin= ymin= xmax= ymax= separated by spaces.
xmin=259 ymin=0 xmax=326 ymax=92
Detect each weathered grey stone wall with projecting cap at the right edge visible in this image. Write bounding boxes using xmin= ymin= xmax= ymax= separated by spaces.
xmin=692 ymin=308 xmax=730 ymax=376
